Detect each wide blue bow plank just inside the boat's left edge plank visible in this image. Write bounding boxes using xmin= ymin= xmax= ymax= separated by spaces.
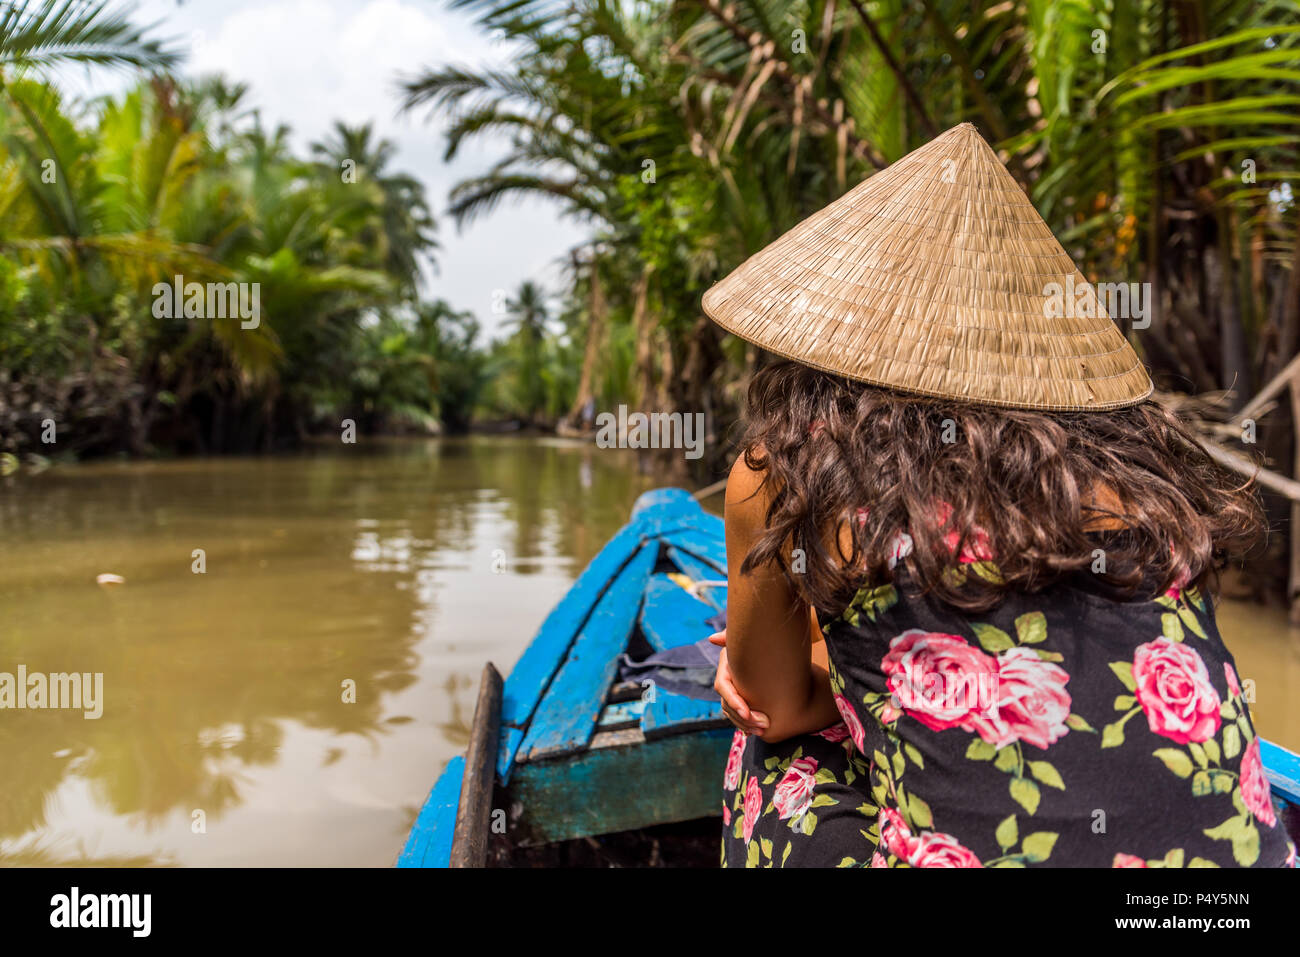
xmin=519 ymin=540 xmax=659 ymax=761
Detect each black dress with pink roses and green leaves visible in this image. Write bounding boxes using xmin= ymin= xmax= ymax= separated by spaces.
xmin=722 ymin=546 xmax=1296 ymax=867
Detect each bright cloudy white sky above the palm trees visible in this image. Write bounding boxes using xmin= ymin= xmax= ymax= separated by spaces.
xmin=62 ymin=0 xmax=588 ymax=334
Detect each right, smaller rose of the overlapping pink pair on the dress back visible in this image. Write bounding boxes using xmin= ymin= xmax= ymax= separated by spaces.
xmin=980 ymin=648 xmax=1070 ymax=750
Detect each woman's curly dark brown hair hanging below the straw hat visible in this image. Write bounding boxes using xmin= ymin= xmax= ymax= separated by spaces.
xmin=741 ymin=361 xmax=1262 ymax=611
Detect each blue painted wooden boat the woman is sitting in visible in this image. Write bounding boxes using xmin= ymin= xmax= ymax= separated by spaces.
xmin=397 ymin=489 xmax=1300 ymax=867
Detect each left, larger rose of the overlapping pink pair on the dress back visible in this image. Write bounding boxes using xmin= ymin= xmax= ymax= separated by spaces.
xmin=880 ymin=628 xmax=997 ymax=735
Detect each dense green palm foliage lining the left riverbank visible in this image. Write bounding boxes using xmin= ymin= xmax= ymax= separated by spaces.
xmin=0 ymin=55 xmax=454 ymax=454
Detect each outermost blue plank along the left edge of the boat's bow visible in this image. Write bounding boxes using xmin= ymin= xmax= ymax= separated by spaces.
xmin=497 ymin=521 xmax=642 ymax=784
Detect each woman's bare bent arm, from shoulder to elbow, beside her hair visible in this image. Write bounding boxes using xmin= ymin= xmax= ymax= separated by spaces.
xmin=727 ymin=455 xmax=839 ymax=742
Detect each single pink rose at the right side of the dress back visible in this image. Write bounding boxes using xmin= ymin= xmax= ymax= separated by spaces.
xmin=1134 ymin=638 xmax=1221 ymax=744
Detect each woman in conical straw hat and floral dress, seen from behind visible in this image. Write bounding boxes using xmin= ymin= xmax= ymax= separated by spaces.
xmin=705 ymin=125 xmax=1295 ymax=867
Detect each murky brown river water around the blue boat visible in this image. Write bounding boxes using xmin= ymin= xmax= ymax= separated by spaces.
xmin=0 ymin=437 xmax=1300 ymax=866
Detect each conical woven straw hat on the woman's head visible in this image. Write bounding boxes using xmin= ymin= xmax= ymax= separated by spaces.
xmin=703 ymin=124 xmax=1152 ymax=410
